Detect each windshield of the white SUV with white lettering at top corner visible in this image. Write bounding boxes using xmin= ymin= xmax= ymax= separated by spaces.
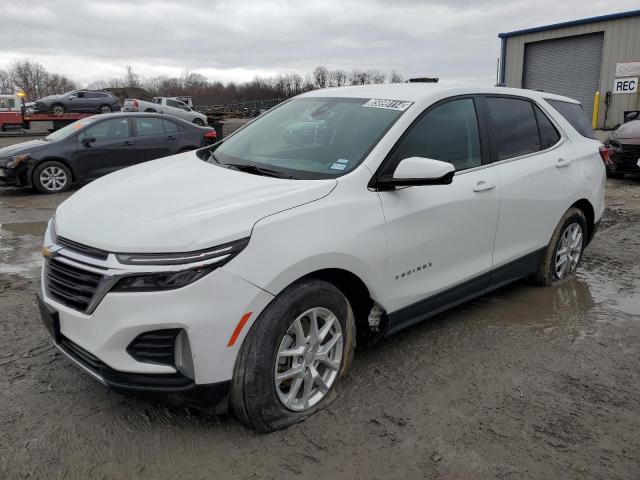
xmin=205 ymin=97 xmax=411 ymax=179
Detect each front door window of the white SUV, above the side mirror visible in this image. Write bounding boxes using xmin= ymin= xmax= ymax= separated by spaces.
xmin=390 ymin=98 xmax=482 ymax=171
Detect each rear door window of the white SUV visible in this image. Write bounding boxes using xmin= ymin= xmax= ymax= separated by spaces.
xmin=487 ymin=97 xmax=541 ymax=160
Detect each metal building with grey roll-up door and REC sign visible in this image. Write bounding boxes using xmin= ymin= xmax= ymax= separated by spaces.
xmin=498 ymin=10 xmax=640 ymax=128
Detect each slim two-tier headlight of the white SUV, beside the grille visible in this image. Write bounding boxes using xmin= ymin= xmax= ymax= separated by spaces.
xmin=113 ymin=238 xmax=249 ymax=292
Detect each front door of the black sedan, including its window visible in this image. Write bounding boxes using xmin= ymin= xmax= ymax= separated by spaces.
xmin=72 ymin=116 xmax=136 ymax=179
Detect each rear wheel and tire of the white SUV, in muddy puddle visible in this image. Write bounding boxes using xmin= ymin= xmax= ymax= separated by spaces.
xmin=533 ymin=207 xmax=588 ymax=286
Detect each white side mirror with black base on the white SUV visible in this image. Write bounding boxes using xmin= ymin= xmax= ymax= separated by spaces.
xmin=375 ymin=157 xmax=456 ymax=189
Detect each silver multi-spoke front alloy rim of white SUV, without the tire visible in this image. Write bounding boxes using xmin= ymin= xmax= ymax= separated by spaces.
xmin=274 ymin=307 xmax=343 ymax=411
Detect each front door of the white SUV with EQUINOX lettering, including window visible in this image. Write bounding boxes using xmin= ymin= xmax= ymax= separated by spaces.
xmin=379 ymin=98 xmax=500 ymax=329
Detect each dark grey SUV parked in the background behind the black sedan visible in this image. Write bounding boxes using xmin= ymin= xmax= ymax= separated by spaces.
xmin=33 ymin=90 xmax=120 ymax=115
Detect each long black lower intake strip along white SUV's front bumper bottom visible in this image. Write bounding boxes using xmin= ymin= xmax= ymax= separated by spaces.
xmin=58 ymin=335 xmax=193 ymax=390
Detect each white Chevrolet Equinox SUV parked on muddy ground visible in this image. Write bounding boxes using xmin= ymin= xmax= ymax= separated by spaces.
xmin=39 ymin=84 xmax=605 ymax=431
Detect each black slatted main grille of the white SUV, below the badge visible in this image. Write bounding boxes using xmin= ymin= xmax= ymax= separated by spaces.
xmin=45 ymin=258 xmax=102 ymax=312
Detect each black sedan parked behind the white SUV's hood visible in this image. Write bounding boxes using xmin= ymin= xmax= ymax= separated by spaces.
xmin=0 ymin=113 xmax=216 ymax=193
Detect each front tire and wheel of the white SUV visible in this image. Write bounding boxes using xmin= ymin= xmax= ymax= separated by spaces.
xmin=231 ymin=279 xmax=356 ymax=432
